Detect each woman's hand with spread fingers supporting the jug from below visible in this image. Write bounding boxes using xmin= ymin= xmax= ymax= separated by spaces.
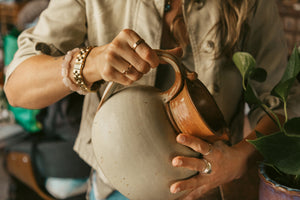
xmin=170 ymin=134 xmax=249 ymax=200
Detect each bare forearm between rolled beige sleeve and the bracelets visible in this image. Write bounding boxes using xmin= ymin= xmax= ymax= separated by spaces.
xmin=4 ymin=55 xmax=70 ymax=109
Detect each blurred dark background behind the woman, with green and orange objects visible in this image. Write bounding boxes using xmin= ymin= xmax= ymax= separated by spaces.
xmin=0 ymin=0 xmax=300 ymax=200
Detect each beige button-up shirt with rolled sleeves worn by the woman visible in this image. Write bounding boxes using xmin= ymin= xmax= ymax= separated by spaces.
xmin=6 ymin=0 xmax=300 ymax=196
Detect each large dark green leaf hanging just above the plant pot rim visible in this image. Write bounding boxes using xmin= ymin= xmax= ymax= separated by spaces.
xmin=249 ymin=132 xmax=300 ymax=175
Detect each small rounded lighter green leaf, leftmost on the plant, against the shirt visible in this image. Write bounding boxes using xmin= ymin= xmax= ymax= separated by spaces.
xmin=232 ymin=52 xmax=256 ymax=90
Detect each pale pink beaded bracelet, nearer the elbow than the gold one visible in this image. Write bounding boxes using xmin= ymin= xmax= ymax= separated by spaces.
xmin=61 ymin=48 xmax=87 ymax=95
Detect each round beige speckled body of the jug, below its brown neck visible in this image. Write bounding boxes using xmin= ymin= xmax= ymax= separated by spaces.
xmin=92 ymin=86 xmax=198 ymax=200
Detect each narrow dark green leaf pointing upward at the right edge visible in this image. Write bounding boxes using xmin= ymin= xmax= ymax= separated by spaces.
xmin=271 ymin=47 xmax=300 ymax=102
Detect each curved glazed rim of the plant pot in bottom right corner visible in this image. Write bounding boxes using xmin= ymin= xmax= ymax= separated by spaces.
xmin=258 ymin=164 xmax=300 ymax=197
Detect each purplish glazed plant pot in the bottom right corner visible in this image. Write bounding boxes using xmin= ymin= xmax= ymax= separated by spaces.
xmin=259 ymin=165 xmax=300 ymax=200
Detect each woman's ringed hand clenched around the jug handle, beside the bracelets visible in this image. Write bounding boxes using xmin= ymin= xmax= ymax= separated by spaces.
xmin=83 ymin=29 xmax=159 ymax=85
